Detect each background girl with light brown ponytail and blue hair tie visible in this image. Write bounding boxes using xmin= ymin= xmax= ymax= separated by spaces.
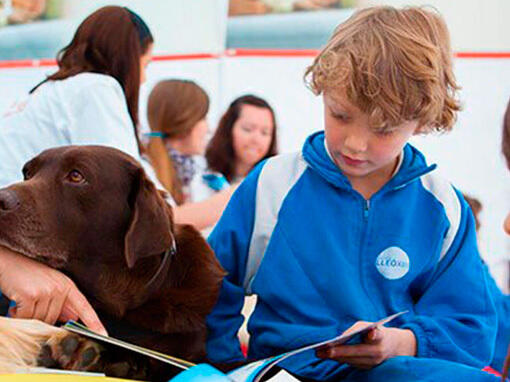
xmin=147 ymin=80 xmax=229 ymax=205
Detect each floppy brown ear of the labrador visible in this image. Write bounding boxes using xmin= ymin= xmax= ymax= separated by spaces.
xmin=124 ymin=168 xmax=174 ymax=268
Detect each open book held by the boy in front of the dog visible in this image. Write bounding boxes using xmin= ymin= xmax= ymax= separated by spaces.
xmin=64 ymin=311 xmax=407 ymax=382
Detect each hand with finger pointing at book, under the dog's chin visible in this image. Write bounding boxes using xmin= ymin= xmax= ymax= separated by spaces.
xmin=0 ymin=247 xmax=106 ymax=334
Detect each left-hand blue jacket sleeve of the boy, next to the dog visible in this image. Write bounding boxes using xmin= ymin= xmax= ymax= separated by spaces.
xmin=207 ymin=164 xmax=263 ymax=363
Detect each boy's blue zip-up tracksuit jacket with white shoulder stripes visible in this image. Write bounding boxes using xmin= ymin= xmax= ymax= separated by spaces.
xmin=207 ymin=132 xmax=497 ymax=380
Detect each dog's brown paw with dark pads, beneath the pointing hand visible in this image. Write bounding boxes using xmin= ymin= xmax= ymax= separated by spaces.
xmin=38 ymin=332 xmax=104 ymax=371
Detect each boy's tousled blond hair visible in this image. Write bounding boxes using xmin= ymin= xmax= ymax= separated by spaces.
xmin=305 ymin=6 xmax=460 ymax=132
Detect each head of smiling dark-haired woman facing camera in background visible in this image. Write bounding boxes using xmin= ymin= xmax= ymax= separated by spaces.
xmin=205 ymin=94 xmax=278 ymax=183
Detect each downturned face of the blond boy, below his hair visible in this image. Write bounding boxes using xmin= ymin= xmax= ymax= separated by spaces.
xmin=324 ymin=93 xmax=418 ymax=186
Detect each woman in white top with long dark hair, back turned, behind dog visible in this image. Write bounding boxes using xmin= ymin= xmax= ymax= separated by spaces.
xmin=0 ymin=6 xmax=154 ymax=186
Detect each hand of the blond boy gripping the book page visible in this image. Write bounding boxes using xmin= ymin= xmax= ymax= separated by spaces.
xmin=316 ymin=321 xmax=416 ymax=369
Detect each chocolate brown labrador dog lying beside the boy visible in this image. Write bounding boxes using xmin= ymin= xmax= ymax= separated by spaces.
xmin=0 ymin=146 xmax=225 ymax=380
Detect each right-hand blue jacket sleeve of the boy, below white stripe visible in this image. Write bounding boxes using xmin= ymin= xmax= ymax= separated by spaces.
xmin=402 ymin=192 xmax=497 ymax=367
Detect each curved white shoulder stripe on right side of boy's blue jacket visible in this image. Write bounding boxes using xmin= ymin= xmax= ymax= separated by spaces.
xmin=421 ymin=172 xmax=461 ymax=261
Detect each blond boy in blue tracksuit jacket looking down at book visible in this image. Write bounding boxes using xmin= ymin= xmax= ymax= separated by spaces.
xmin=208 ymin=7 xmax=496 ymax=381
